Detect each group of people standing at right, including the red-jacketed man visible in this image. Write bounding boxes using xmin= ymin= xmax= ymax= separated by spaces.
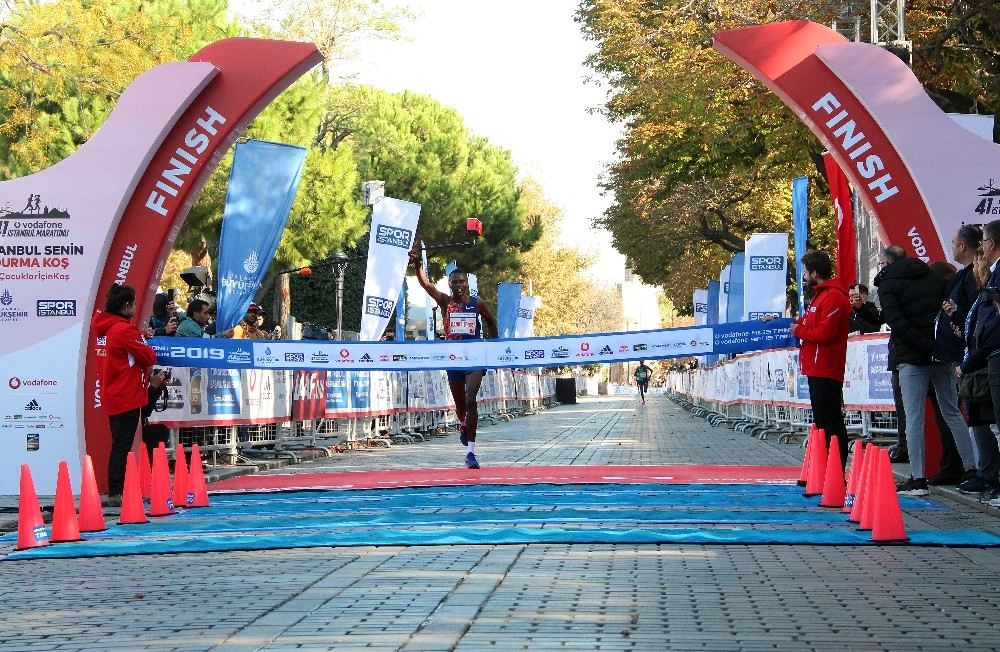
xmin=792 ymin=220 xmax=1000 ymax=507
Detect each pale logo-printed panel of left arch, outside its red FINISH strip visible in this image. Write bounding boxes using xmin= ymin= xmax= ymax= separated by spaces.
xmin=0 ymin=64 xmax=217 ymax=495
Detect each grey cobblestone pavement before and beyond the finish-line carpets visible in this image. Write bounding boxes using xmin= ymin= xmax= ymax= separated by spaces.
xmin=0 ymin=397 xmax=1000 ymax=652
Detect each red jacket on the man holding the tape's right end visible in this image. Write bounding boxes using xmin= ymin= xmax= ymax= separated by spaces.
xmin=795 ymin=280 xmax=851 ymax=382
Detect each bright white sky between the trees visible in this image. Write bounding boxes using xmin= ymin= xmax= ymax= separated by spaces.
xmin=241 ymin=0 xmax=625 ymax=282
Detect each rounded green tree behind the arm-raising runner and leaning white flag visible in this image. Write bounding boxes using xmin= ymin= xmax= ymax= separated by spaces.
xmin=334 ymin=86 xmax=541 ymax=279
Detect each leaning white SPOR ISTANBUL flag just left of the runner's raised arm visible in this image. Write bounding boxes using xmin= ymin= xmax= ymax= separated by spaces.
xmin=358 ymin=197 xmax=420 ymax=342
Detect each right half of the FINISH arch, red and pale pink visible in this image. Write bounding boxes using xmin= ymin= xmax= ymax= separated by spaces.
xmin=715 ymin=21 xmax=1000 ymax=261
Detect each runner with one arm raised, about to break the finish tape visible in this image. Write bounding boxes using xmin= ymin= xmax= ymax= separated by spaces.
xmin=410 ymin=249 xmax=497 ymax=469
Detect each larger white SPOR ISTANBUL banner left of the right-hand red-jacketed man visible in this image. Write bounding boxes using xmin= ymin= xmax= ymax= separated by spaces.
xmin=743 ymin=233 xmax=788 ymax=321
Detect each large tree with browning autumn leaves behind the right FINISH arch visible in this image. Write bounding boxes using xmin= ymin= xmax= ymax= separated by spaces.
xmin=577 ymin=0 xmax=1000 ymax=306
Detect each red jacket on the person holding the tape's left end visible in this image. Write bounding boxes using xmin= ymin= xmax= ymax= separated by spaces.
xmin=91 ymin=310 xmax=156 ymax=415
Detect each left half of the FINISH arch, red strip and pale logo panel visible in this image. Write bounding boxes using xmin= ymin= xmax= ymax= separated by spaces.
xmin=0 ymin=38 xmax=322 ymax=495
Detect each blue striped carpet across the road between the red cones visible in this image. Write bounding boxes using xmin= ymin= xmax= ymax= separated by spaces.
xmin=0 ymin=484 xmax=1000 ymax=560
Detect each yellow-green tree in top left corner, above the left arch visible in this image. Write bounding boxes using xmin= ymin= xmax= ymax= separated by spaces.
xmin=0 ymin=0 xmax=236 ymax=178
